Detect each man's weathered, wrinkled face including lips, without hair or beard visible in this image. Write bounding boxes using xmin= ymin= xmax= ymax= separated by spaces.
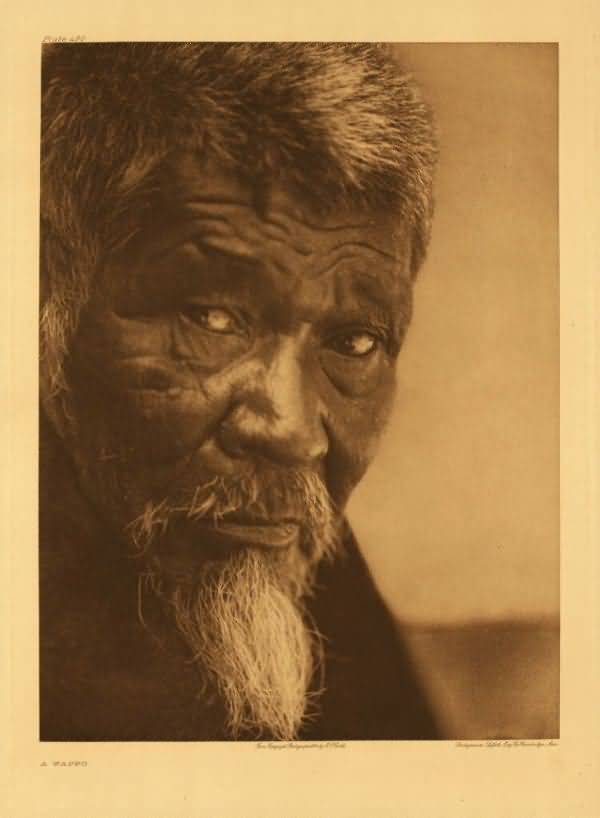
xmin=63 ymin=155 xmax=411 ymax=561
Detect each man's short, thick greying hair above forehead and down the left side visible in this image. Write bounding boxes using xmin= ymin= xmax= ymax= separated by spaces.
xmin=41 ymin=43 xmax=436 ymax=393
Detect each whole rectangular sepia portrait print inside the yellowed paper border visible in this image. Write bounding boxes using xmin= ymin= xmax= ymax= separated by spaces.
xmin=39 ymin=42 xmax=560 ymax=742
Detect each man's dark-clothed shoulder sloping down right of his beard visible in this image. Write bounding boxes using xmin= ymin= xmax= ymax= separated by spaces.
xmin=302 ymin=527 xmax=437 ymax=739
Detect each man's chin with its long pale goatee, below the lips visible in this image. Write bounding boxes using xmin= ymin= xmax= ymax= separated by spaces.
xmin=141 ymin=547 xmax=320 ymax=740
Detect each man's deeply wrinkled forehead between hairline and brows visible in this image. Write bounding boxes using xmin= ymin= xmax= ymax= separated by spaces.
xmin=146 ymin=153 xmax=410 ymax=278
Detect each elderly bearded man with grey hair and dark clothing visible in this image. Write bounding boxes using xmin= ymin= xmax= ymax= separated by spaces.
xmin=40 ymin=43 xmax=436 ymax=740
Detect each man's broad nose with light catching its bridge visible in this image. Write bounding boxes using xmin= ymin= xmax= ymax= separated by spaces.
xmin=219 ymin=337 xmax=328 ymax=467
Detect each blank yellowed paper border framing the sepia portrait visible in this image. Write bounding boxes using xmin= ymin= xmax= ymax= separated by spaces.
xmin=0 ymin=0 xmax=600 ymax=818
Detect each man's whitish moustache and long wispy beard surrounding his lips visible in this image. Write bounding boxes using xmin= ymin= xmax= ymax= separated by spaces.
xmin=129 ymin=467 xmax=339 ymax=740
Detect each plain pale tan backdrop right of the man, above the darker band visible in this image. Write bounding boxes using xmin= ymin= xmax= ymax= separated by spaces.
xmin=349 ymin=43 xmax=559 ymax=624
